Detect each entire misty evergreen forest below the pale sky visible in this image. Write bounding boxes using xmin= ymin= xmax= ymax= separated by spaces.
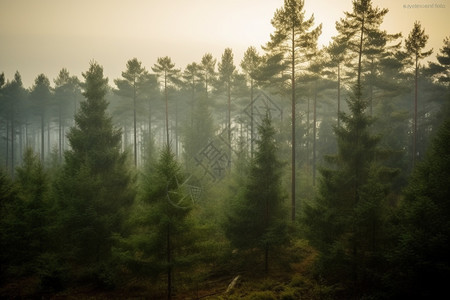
xmin=0 ymin=0 xmax=450 ymax=300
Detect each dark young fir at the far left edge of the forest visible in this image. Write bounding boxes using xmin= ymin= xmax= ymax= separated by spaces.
xmin=0 ymin=149 xmax=51 ymax=276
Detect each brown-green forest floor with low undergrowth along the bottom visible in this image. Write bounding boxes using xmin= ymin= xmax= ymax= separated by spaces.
xmin=0 ymin=240 xmax=332 ymax=300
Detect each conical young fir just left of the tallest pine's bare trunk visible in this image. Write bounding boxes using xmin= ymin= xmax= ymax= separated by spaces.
xmin=224 ymin=115 xmax=288 ymax=272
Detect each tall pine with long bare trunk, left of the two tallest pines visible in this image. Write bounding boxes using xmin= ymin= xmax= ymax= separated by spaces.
xmin=265 ymin=0 xmax=322 ymax=221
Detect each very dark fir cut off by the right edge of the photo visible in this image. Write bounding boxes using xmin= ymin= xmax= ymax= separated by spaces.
xmin=386 ymin=109 xmax=450 ymax=299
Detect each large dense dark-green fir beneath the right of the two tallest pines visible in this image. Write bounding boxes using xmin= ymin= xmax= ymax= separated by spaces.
xmin=303 ymin=86 xmax=395 ymax=297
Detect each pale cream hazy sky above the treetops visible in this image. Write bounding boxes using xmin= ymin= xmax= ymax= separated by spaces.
xmin=0 ymin=0 xmax=450 ymax=87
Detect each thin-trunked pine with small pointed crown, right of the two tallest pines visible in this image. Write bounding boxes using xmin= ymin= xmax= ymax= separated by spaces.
xmin=405 ymin=22 xmax=433 ymax=167
